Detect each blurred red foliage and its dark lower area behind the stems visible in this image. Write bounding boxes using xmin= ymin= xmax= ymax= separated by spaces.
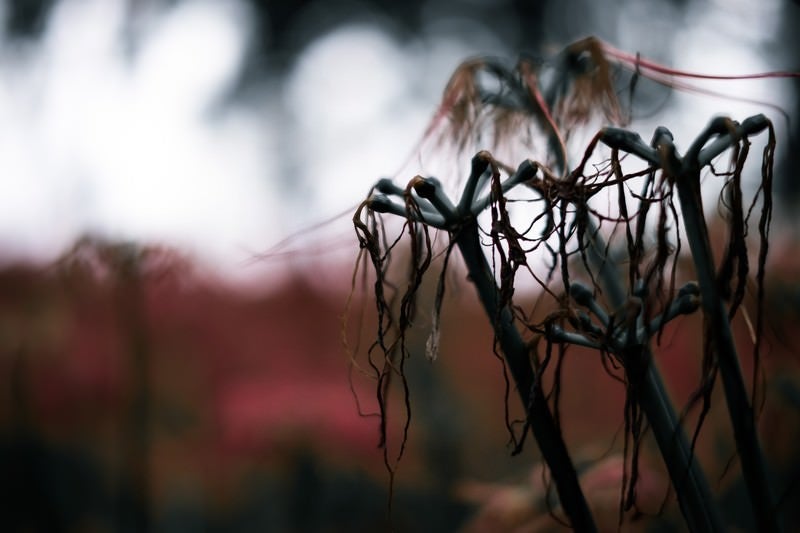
xmin=0 ymin=232 xmax=800 ymax=531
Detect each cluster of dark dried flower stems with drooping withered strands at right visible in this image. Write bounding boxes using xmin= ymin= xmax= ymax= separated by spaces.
xmin=346 ymin=35 xmax=780 ymax=530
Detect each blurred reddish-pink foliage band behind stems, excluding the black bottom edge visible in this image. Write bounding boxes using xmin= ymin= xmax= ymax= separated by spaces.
xmin=0 ymin=232 xmax=800 ymax=531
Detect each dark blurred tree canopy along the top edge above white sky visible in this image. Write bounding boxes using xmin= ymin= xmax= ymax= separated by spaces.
xmin=4 ymin=0 xmax=800 ymax=205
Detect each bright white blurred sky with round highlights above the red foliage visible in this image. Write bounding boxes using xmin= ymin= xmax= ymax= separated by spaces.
xmin=0 ymin=0 xmax=792 ymax=280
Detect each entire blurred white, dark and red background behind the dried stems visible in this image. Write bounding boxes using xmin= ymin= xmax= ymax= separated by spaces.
xmin=0 ymin=0 xmax=800 ymax=532
